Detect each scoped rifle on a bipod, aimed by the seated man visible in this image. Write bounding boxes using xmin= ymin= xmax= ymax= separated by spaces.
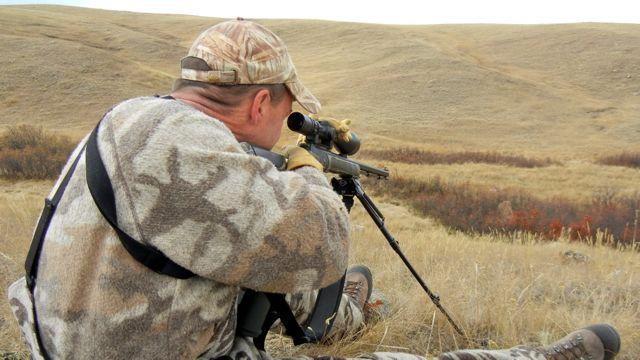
xmin=242 ymin=112 xmax=466 ymax=338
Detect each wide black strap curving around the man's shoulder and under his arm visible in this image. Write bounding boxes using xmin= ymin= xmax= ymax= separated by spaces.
xmin=86 ymin=119 xmax=195 ymax=279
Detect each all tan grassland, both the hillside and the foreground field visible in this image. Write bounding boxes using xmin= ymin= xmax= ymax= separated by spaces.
xmin=0 ymin=6 xmax=640 ymax=359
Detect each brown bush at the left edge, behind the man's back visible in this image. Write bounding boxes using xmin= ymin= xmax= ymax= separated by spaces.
xmin=0 ymin=125 xmax=74 ymax=179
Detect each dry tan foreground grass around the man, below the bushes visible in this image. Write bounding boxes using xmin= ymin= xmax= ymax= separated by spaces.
xmin=0 ymin=182 xmax=640 ymax=359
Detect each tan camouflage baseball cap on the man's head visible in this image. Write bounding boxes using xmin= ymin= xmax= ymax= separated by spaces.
xmin=181 ymin=19 xmax=321 ymax=114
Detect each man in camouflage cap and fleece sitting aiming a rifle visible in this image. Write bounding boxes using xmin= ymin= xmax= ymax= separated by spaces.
xmin=10 ymin=20 xmax=619 ymax=360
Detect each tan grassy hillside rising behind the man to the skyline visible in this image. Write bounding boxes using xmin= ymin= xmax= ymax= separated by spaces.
xmin=0 ymin=6 xmax=640 ymax=157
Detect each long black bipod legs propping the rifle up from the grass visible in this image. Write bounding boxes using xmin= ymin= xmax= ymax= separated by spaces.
xmin=331 ymin=176 xmax=467 ymax=339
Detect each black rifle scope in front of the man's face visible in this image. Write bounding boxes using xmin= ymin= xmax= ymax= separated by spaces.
xmin=287 ymin=112 xmax=360 ymax=155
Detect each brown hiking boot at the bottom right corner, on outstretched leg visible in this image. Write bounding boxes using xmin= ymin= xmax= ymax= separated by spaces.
xmin=537 ymin=324 xmax=620 ymax=360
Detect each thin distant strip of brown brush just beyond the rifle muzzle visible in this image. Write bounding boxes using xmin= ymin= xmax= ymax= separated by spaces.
xmin=360 ymin=148 xmax=558 ymax=168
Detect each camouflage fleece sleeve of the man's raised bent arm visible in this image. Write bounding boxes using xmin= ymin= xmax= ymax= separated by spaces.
xmin=104 ymin=102 xmax=349 ymax=293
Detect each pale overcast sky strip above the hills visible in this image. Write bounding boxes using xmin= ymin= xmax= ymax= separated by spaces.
xmin=0 ymin=0 xmax=640 ymax=24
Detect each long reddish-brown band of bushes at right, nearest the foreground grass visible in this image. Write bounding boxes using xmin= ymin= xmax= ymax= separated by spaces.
xmin=365 ymin=177 xmax=640 ymax=249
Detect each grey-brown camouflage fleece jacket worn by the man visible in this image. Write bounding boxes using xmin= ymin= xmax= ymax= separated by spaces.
xmin=10 ymin=97 xmax=349 ymax=359
